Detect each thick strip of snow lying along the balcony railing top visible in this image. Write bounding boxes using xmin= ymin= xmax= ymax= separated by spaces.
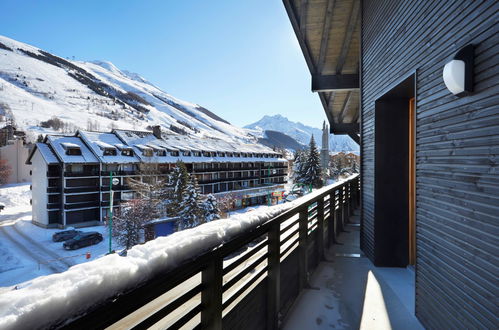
xmin=0 ymin=182 xmax=352 ymax=329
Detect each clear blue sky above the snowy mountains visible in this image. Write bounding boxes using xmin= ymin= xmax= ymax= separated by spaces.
xmin=0 ymin=0 xmax=325 ymax=127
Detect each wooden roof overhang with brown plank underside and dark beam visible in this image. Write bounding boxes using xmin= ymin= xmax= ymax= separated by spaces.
xmin=283 ymin=0 xmax=360 ymax=140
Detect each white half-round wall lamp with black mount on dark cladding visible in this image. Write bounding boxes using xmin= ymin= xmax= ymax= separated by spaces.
xmin=443 ymin=44 xmax=475 ymax=96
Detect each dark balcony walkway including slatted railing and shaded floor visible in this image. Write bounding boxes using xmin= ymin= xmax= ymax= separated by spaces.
xmin=52 ymin=176 xmax=386 ymax=329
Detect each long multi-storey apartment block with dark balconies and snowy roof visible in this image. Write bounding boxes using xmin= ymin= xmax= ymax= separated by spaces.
xmin=27 ymin=128 xmax=287 ymax=227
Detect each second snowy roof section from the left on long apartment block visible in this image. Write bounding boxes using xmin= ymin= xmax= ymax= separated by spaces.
xmin=78 ymin=131 xmax=140 ymax=164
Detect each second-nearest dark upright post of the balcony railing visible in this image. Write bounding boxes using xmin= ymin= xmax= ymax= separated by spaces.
xmin=267 ymin=222 xmax=281 ymax=329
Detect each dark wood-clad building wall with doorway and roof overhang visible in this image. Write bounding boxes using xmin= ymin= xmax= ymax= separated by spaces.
xmin=283 ymin=0 xmax=499 ymax=329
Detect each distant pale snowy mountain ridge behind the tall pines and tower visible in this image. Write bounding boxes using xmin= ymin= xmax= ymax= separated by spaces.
xmin=244 ymin=115 xmax=359 ymax=151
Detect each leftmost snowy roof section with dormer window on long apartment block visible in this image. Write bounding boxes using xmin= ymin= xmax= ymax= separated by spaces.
xmin=47 ymin=135 xmax=99 ymax=163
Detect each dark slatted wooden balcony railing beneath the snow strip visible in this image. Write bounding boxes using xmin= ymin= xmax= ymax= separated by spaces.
xmin=60 ymin=175 xmax=360 ymax=329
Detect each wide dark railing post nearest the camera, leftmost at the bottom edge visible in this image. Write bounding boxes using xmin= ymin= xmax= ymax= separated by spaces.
xmin=201 ymin=255 xmax=223 ymax=329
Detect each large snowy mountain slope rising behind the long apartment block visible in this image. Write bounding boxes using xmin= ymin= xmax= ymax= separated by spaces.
xmin=0 ymin=36 xmax=258 ymax=143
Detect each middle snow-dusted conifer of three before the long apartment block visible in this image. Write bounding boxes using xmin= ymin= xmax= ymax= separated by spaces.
xmin=178 ymin=176 xmax=205 ymax=230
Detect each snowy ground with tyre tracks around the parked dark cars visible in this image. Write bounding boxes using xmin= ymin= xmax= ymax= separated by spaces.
xmin=0 ymin=183 xmax=120 ymax=293
